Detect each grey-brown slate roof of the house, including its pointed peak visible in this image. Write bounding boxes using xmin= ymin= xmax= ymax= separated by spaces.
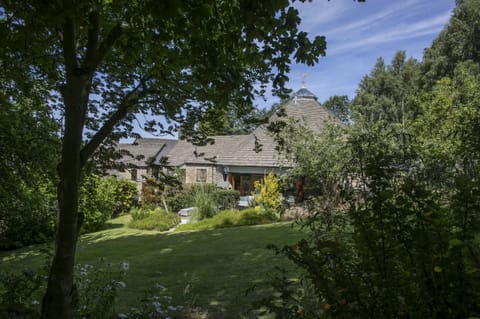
xmin=120 ymin=88 xmax=341 ymax=168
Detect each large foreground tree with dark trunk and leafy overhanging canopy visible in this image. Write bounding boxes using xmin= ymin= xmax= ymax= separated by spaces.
xmin=0 ymin=0 xmax=325 ymax=319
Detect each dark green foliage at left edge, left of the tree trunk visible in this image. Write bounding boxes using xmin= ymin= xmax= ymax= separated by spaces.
xmin=0 ymin=95 xmax=59 ymax=250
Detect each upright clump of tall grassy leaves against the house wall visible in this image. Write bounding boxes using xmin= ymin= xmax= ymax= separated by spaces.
xmin=191 ymin=184 xmax=218 ymax=220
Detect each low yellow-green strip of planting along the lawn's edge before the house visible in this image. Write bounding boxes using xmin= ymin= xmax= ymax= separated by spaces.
xmin=176 ymin=206 xmax=278 ymax=231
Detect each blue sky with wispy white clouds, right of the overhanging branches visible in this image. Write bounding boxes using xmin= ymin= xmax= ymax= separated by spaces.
xmin=282 ymin=0 xmax=455 ymax=106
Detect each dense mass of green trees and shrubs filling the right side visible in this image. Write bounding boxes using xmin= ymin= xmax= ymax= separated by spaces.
xmin=259 ymin=0 xmax=480 ymax=318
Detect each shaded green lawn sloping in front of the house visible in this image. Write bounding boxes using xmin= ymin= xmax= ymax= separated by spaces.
xmin=0 ymin=217 xmax=308 ymax=318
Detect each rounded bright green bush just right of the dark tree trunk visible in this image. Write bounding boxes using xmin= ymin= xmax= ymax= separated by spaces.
xmin=79 ymin=175 xmax=138 ymax=233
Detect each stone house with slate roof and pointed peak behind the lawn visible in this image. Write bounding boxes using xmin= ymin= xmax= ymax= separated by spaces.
xmin=113 ymin=88 xmax=340 ymax=199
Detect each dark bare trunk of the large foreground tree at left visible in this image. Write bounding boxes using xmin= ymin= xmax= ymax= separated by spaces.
xmin=42 ymin=79 xmax=88 ymax=319
